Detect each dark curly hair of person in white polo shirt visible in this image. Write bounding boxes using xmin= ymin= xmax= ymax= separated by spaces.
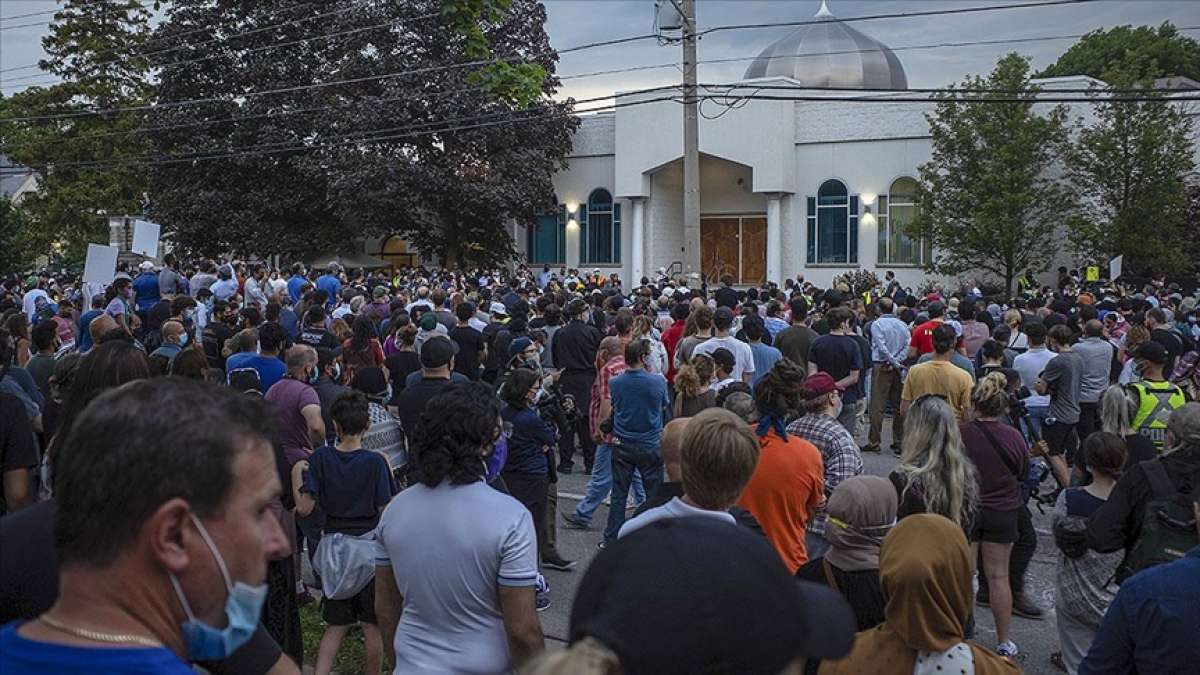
xmin=412 ymin=382 xmax=500 ymax=488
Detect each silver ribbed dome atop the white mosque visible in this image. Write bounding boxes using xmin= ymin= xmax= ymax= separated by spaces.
xmin=745 ymin=0 xmax=908 ymax=89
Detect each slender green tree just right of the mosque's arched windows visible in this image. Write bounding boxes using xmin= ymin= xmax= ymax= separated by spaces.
xmin=906 ymin=54 xmax=1072 ymax=292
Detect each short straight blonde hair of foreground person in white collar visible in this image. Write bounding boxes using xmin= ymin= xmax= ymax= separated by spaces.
xmin=680 ymin=408 xmax=758 ymax=510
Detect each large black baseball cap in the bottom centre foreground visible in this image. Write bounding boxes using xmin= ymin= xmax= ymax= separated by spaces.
xmin=570 ymin=518 xmax=856 ymax=675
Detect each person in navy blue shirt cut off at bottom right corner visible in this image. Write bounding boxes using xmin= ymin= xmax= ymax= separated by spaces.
xmin=1079 ymin=472 xmax=1200 ymax=675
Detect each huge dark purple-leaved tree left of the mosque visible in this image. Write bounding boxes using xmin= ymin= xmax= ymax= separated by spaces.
xmin=151 ymin=0 xmax=577 ymax=262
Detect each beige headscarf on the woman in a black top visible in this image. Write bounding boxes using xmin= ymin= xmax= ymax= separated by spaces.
xmin=824 ymin=476 xmax=898 ymax=572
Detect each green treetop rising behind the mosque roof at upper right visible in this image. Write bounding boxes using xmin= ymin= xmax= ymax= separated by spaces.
xmin=1036 ymin=22 xmax=1200 ymax=82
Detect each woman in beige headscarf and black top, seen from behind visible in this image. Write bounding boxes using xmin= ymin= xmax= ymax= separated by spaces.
xmin=796 ymin=476 xmax=896 ymax=673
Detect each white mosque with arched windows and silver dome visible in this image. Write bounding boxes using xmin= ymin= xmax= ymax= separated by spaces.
xmin=512 ymin=2 xmax=1103 ymax=288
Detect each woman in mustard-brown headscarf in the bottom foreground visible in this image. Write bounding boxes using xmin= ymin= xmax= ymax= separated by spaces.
xmin=820 ymin=514 xmax=1020 ymax=675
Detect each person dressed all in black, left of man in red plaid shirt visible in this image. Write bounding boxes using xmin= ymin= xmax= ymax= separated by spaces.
xmin=551 ymin=298 xmax=604 ymax=473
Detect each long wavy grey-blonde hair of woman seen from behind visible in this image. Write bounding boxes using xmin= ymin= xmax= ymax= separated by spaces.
xmin=896 ymin=396 xmax=976 ymax=527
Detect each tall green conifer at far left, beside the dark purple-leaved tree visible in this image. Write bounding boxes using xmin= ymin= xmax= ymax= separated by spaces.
xmin=0 ymin=0 xmax=151 ymax=253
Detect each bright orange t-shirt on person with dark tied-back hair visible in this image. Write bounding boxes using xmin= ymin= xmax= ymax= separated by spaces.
xmin=738 ymin=430 xmax=824 ymax=566
